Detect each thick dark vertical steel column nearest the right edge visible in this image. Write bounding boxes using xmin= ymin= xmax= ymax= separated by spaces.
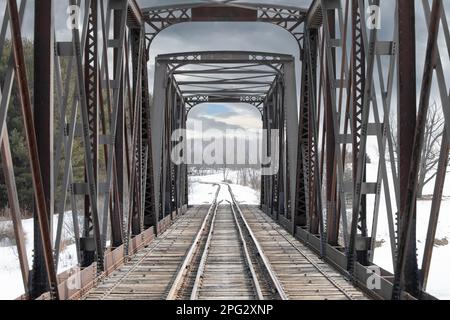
xmin=396 ymin=0 xmax=418 ymax=294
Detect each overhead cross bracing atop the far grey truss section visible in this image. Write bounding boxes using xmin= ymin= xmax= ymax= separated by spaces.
xmin=156 ymin=51 xmax=293 ymax=112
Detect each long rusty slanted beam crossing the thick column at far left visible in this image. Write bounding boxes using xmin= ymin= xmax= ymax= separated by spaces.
xmin=8 ymin=0 xmax=59 ymax=299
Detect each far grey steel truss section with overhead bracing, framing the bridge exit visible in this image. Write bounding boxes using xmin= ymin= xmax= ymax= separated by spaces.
xmin=151 ymin=51 xmax=298 ymax=225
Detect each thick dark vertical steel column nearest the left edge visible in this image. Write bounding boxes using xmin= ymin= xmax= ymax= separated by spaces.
xmin=30 ymin=0 xmax=54 ymax=298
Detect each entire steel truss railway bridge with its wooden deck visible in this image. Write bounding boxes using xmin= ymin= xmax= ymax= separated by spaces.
xmin=0 ymin=0 xmax=450 ymax=299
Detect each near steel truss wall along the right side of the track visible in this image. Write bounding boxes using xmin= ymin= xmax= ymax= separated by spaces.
xmin=296 ymin=0 xmax=449 ymax=299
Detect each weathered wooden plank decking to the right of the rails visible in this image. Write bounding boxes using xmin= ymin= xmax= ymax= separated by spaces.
xmin=242 ymin=206 xmax=367 ymax=300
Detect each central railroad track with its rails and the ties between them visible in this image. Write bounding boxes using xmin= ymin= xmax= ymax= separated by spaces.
xmin=167 ymin=187 xmax=287 ymax=300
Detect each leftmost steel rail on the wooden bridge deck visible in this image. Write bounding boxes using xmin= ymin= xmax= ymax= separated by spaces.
xmin=166 ymin=184 xmax=221 ymax=300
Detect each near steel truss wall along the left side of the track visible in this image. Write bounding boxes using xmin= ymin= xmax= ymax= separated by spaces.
xmin=0 ymin=0 xmax=156 ymax=299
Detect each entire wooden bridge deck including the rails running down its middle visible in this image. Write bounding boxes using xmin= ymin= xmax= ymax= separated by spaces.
xmin=81 ymin=184 xmax=366 ymax=300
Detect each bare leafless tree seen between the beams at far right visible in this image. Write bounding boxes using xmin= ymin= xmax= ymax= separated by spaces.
xmin=391 ymin=102 xmax=445 ymax=198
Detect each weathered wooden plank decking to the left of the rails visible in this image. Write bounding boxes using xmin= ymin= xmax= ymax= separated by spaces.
xmin=83 ymin=186 xmax=220 ymax=300
